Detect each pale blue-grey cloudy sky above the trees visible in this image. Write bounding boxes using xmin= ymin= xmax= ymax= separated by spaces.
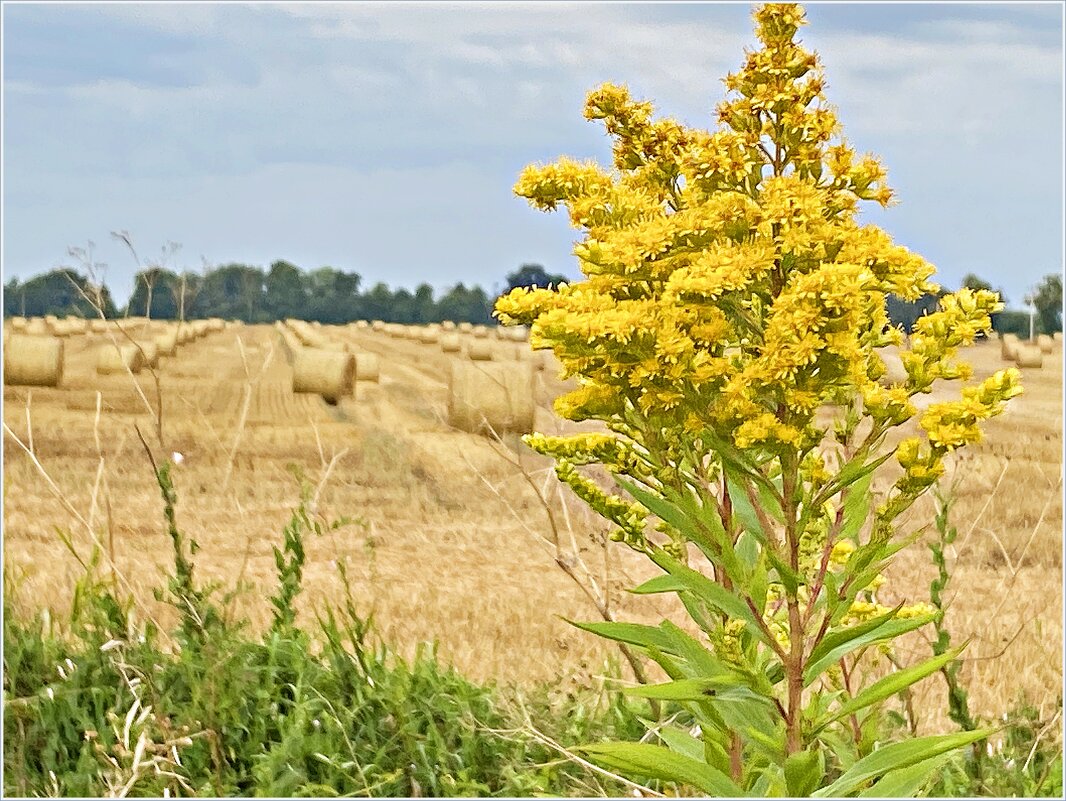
xmin=3 ymin=2 xmax=1063 ymax=306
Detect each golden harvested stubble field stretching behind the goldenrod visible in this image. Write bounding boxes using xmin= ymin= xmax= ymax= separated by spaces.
xmin=4 ymin=326 xmax=1063 ymax=728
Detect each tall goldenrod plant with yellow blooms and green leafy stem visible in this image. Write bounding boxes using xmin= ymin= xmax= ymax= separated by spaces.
xmin=497 ymin=3 xmax=1021 ymax=797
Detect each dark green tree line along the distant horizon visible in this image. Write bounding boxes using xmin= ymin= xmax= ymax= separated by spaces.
xmin=3 ymin=260 xmax=1063 ymax=337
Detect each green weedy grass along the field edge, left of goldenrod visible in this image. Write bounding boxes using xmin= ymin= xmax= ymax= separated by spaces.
xmin=3 ymin=467 xmax=645 ymax=796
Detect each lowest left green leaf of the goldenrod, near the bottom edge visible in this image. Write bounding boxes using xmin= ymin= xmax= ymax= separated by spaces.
xmin=575 ymin=742 xmax=746 ymax=798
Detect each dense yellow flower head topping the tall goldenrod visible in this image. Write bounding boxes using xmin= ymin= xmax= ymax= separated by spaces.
xmin=496 ymin=3 xmax=1020 ymax=639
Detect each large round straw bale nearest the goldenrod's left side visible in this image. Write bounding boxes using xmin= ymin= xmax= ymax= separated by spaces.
xmin=448 ymin=362 xmax=536 ymax=434
